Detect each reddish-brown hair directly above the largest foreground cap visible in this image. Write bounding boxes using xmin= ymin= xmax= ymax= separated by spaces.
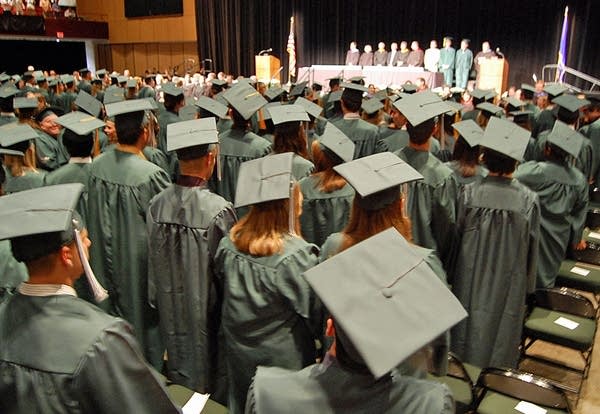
xmin=340 ymin=194 xmax=412 ymax=252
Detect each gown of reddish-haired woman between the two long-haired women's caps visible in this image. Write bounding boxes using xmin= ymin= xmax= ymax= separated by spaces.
xmin=299 ymin=175 xmax=354 ymax=246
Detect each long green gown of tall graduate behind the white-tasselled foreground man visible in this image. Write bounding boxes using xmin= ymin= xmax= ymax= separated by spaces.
xmin=88 ymin=150 xmax=169 ymax=367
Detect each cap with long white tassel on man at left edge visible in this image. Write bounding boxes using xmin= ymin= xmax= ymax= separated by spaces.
xmin=0 ymin=183 xmax=108 ymax=302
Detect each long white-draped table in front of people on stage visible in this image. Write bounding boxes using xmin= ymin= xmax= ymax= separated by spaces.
xmin=297 ymin=65 xmax=444 ymax=89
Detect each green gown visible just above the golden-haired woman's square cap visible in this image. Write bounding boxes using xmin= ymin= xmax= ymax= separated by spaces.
xmin=210 ymin=128 xmax=271 ymax=204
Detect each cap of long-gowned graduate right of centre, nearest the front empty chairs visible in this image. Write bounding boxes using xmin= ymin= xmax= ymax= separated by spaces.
xmin=479 ymin=117 xmax=531 ymax=161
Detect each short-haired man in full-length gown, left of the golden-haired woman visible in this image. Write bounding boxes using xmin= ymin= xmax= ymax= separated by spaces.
xmin=146 ymin=118 xmax=236 ymax=403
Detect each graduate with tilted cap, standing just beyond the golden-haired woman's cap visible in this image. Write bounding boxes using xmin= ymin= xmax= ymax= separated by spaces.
xmin=210 ymin=82 xmax=271 ymax=209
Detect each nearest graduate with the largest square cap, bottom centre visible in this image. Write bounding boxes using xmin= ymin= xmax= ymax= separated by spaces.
xmin=246 ymin=229 xmax=467 ymax=414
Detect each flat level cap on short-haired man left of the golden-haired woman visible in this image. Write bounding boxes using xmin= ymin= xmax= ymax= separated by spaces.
xmin=167 ymin=118 xmax=219 ymax=151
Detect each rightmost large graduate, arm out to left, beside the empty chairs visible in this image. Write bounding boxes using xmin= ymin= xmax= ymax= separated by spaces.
xmin=515 ymin=121 xmax=589 ymax=288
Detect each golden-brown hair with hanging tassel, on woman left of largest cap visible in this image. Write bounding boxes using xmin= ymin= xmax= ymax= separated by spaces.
xmin=229 ymin=184 xmax=302 ymax=257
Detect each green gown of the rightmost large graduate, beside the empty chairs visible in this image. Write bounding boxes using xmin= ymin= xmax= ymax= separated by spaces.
xmin=515 ymin=161 xmax=588 ymax=287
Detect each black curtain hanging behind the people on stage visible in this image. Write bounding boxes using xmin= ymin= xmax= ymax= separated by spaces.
xmin=196 ymin=0 xmax=600 ymax=84
